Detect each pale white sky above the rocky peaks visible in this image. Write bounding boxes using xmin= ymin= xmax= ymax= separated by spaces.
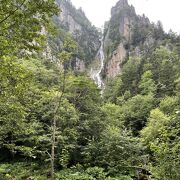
xmin=71 ymin=0 xmax=180 ymax=34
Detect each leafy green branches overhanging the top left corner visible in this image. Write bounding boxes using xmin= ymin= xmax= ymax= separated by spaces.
xmin=0 ymin=0 xmax=58 ymax=56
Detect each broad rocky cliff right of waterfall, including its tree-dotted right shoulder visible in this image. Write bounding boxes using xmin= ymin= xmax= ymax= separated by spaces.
xmin=104 ymin=0 xmax=157 ymax=78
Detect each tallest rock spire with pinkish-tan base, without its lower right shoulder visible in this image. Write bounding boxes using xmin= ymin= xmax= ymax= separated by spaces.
xmin=104 ymin=0 xmax=135 ymax=78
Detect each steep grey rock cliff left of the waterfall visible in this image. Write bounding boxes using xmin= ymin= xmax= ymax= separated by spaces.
xmin=55 ymin=0 xmax=100 ymax=69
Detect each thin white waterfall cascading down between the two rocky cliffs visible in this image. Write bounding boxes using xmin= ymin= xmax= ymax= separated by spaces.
xmin=91 ymin=38 xmax=104 ymax=93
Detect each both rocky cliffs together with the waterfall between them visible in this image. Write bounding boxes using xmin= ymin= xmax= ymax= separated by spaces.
xmin=55 ymin=0 xmax=162 ymax=88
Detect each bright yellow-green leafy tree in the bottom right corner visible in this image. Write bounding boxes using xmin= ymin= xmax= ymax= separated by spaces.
xmin=141 ymin=109 xmax=180 ymax=180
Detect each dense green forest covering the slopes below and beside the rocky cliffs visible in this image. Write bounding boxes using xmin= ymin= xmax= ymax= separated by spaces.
xmin=0 ymin=0 xmax=180 ymax=180
